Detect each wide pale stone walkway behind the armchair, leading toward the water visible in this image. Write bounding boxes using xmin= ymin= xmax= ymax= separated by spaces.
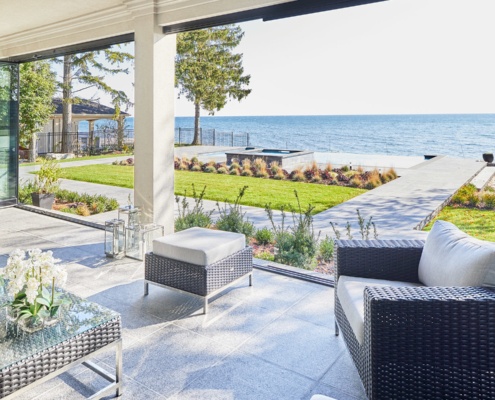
xmin=314 ymin=156 xmax=486 ymax=239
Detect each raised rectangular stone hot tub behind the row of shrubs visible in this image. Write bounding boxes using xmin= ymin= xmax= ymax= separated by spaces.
xmin=225 ymin=147 xmax=314 ymax=168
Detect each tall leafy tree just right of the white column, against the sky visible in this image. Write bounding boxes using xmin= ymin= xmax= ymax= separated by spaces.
xmin=175 ymin=25 xmax=251 ymax=144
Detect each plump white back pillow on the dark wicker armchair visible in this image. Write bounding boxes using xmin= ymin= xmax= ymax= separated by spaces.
xmin=418 ymin=221 xmax=495 ymax=286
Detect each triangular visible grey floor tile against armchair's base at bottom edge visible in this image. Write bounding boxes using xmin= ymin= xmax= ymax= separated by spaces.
xmin=320 ymin=351 xmax=366 ymax=398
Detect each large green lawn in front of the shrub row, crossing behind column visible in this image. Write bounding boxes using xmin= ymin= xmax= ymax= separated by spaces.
xmin=62 ymin=164 xmax=366 ymax=214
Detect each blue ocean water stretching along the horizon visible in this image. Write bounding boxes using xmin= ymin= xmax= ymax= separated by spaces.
xmin=80 ymin=114 xmax=495 ymax=159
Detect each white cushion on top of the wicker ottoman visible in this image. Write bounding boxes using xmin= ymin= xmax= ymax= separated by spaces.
xmin=153 ymin=228 xmax=246 ymax=266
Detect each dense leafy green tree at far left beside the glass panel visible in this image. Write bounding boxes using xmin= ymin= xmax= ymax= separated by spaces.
xmin=19 ymin=60 xmax=57 ymax=161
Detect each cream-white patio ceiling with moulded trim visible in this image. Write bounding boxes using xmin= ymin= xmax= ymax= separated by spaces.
xmin=0 ymin=0 xmax=294 ymax=59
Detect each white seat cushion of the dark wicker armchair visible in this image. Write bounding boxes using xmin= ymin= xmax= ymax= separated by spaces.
xmin=337 ymin=275 xmax=421 ymax=344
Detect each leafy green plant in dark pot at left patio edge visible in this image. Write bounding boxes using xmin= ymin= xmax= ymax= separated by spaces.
xmin=31 ymin=160 xmax=60 ymax=210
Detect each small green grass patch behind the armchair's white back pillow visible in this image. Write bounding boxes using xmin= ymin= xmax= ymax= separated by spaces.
xmin=424 ymin=206 xmax=495 ymax=242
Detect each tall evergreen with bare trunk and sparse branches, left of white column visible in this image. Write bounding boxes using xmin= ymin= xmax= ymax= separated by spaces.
xmin=57 ymin=48 xmax=134 ymax=152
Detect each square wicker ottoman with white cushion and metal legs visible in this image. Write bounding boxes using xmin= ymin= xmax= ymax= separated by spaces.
xmin=144 ymin=228 xmax=253 ymax=314
